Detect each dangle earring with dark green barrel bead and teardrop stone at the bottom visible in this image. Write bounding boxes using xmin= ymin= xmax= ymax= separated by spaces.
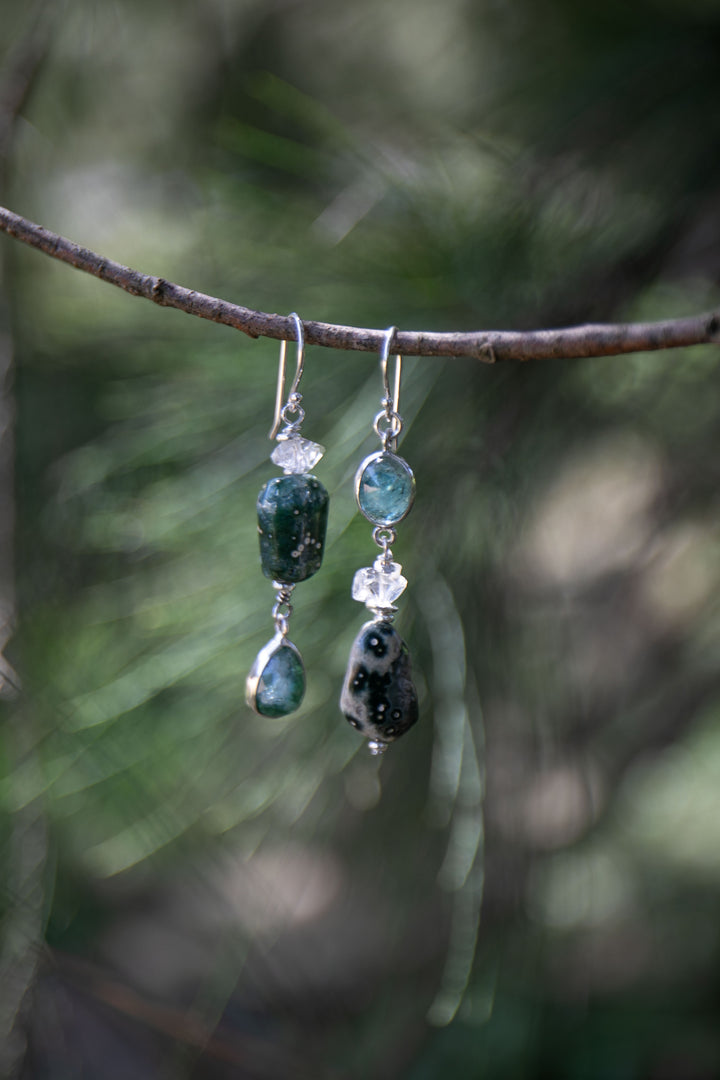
xmin=245 ymin=312 xmax=328 ymax=716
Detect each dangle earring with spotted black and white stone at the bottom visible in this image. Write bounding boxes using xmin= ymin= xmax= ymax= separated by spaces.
xmin=340 ymin=326 xmax=418 ymax=755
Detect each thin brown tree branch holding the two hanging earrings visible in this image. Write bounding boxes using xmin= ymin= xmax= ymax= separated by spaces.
xmin=0 ymin=199 xmax=720 ymax=364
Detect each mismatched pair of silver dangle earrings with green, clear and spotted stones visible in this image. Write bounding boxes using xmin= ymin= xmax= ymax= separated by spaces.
xmin=246 ymin=313 xmax=418 ymax=755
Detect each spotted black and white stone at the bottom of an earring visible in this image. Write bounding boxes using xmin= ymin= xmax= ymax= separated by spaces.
xmin=340 ymin=619 xmax=418 ymax=743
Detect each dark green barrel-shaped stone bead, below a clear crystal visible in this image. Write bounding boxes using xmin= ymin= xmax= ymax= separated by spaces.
xmin=258 ymin=473 xmax=328 ymax=585
